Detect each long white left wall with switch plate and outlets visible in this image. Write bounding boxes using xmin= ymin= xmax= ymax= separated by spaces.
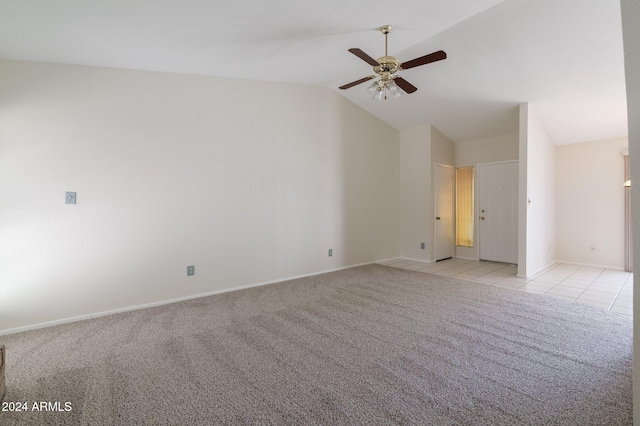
xmin=0 ymin=61 xmax=399 ymax=331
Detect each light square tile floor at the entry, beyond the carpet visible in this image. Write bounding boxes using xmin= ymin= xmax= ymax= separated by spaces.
xmin=380 ymin=259 xmax=633 ymax=318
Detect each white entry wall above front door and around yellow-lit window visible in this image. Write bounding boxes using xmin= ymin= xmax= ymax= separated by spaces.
xmin=454 ymin=133 xmax=518 ymax=259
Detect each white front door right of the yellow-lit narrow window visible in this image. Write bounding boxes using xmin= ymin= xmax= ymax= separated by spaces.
xmin=477 ymin=161 xmax=518 ymax=264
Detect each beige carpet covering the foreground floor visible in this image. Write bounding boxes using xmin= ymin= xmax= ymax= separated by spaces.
xmin=0 ymin=265 xmax=632 ymax=426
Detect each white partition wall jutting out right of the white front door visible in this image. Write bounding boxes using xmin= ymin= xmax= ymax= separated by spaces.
xmin=518 ymin=104 xmax=556 ymax=276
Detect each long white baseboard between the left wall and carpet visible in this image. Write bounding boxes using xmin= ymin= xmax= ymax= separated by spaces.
xmin=0 ymin=261 xmax=379 ymax=336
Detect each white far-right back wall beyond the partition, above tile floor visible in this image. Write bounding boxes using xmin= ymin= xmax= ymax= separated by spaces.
xmin=556 ymin=138 xmax=628 ymax=269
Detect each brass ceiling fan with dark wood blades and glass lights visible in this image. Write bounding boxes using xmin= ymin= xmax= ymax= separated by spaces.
xmin=339 ymin=25 xmax=447 ymax=101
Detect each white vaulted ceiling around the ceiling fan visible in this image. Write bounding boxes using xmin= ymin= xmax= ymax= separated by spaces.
xmin=0 ymin=0 xmax=627 ymax=144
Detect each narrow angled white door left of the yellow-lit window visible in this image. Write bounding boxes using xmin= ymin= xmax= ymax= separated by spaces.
xmin=434 ymin=164 xmax=453 ymax=261
